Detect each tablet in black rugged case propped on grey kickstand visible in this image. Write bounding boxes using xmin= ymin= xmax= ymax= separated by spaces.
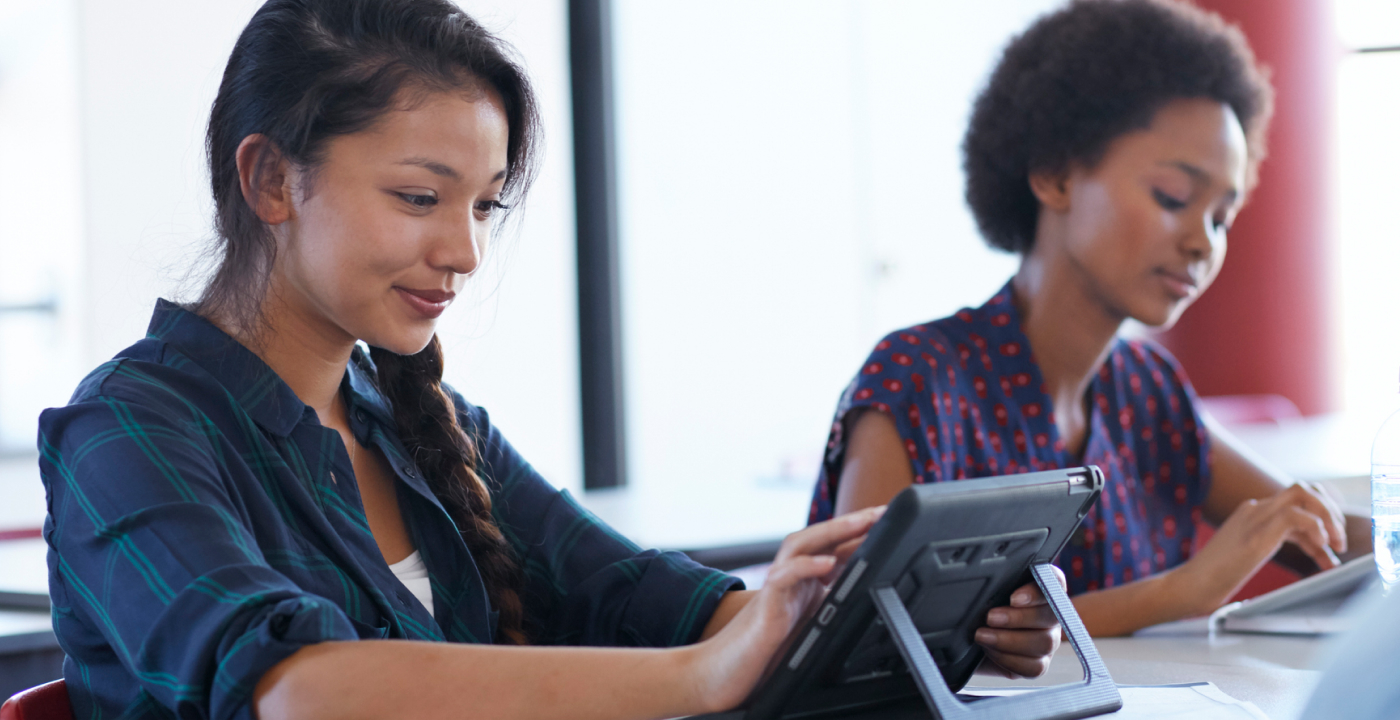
xmin=735 ymin=466 xmax=1121 ymax=720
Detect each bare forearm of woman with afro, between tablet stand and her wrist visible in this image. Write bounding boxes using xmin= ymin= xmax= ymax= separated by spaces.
xmin=1072 ymin=572 xmax=1210 ymax=637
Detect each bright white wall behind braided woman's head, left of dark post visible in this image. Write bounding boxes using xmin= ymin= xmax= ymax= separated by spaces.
xmin=69 ymin=0 xmax=581 ymax=486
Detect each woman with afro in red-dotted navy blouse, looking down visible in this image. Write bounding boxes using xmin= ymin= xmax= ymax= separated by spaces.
xmin=812 ymin=0 xmax=1364 ymax=639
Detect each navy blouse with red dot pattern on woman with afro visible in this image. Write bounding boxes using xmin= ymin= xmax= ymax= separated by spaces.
xmin=809 ymin=283 xmax=1210 ymax=594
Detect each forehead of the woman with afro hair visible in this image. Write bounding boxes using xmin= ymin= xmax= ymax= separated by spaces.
xmin=1103 ymin=99 xmax=1249 ymax=191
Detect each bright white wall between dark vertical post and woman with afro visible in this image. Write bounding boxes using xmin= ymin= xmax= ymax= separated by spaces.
xmin=616 ymin=0 xmax=1060 ymax=486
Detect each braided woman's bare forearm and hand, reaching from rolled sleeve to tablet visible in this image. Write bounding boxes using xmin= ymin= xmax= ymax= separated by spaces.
xmin=253 ymin=510 xmax=881 ymax=720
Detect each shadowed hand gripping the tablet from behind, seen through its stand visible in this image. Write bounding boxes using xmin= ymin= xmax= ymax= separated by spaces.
xmin=976 ymin=567 xmax=1065 ymax=678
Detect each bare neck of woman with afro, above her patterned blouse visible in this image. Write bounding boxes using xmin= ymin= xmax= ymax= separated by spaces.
xmin=1012 ymin=238 xmax=1126 ymax=416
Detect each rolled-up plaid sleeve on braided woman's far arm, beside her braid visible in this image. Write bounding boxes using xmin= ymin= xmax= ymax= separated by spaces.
xmin=455 ymin=396 xmax=743 ymax=647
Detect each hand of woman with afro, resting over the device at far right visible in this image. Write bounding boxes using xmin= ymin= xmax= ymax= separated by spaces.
xmin=1169 ymin=483 xmax=1347 ymax=616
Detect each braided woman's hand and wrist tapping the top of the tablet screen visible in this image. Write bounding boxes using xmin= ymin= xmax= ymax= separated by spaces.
xmin=692 ymin=507 xmax=885 ymax=712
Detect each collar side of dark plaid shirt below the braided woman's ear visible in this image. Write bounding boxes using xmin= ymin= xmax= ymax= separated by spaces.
xmin=146 ymin=300 xmax=308 ymax=437
